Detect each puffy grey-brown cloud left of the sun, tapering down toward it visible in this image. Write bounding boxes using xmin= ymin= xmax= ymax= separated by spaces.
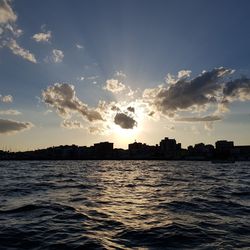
xmin=42 ymin=83 xmax=103 ymax=122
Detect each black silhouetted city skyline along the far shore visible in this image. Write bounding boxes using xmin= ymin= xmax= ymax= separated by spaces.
xmin=0 ymin=137 xmax=250 ymax=161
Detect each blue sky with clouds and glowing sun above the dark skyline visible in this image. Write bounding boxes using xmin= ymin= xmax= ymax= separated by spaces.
xmin=0 ymin=0 xmax=250 ymax=151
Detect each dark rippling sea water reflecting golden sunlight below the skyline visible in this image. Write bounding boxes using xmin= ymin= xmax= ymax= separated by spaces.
xmin=0 ymin=161 xmax=250 ymax=249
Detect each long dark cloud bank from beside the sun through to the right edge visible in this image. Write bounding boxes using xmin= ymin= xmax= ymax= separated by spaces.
xmin=143 ymin=67 xmax=250 ymax=120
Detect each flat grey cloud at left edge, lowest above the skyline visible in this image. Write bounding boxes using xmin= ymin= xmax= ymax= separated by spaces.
xmin=0 ymin=118 xmax=34 ymax=135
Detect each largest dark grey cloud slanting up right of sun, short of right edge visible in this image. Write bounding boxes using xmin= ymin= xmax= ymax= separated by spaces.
xmin=143 ymin=67 xmax=233 ymax=117
